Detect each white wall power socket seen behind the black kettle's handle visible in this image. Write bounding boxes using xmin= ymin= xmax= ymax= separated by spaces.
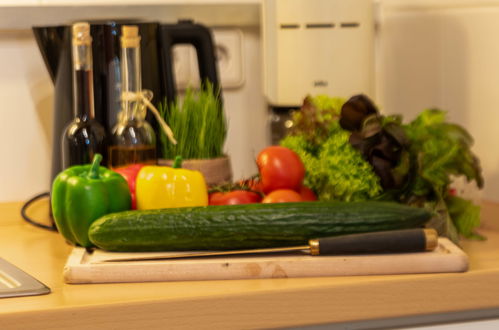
xmin=174 ymin=28 xmax=244 ymax=91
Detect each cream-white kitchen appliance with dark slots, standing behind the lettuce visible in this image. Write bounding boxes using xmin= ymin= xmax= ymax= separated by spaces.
xmin=261 ymin=0 xmax=374 ymax=142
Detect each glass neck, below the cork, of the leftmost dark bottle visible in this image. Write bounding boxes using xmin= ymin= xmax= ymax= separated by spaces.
xmin=73 ymin=43 xmax=95 ymax=120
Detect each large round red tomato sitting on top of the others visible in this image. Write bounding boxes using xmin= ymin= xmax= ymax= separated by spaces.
xmin=256 ymin=146 xmax=305 ymax=193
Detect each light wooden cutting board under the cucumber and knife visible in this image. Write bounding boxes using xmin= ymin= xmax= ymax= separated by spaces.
xmin=64 ymin=238 xmax=468 ymax=283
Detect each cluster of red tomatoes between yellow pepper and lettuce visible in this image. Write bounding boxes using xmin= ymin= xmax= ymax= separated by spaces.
xmin=209 ymin=146 xmax=317 ymax=205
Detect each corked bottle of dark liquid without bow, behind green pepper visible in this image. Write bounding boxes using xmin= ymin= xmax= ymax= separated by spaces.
xmin=62 ymin=23 xmax=107 ymax=169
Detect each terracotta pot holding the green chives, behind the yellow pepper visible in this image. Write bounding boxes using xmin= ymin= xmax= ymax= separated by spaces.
xmin=158 ymin=156 xmax=232 ymax=186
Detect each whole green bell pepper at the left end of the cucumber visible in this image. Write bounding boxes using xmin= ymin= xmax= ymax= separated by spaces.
xmin=51 ymin=154 xmax=131 ymax=247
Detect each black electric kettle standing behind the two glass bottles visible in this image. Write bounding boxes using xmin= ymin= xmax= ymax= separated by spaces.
xmin=33 ymin=20 xmax=219 ymax=181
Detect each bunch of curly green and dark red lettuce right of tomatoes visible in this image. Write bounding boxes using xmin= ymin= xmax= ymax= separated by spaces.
xmin=281 ymin=95 xmax=483 ymax=242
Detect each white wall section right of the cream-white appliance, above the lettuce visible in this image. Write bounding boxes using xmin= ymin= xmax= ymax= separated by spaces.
xmin=377 ymin=0 xmax=499 ymax=201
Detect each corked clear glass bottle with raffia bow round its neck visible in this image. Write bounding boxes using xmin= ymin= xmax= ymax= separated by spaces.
xmin=109 ymin=26 xmax=157 ymax=168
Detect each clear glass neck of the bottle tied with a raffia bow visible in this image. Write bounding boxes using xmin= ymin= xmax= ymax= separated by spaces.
xmin=121 ymin=45 xmax=144 ymax=120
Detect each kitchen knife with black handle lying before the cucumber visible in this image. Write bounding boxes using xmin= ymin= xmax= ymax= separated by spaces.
xmin=101 ymin=228 xmax=438 ymax=262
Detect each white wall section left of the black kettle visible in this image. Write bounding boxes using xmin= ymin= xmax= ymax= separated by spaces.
xmin=0 ymin=30 xmax=53 ymax=201
